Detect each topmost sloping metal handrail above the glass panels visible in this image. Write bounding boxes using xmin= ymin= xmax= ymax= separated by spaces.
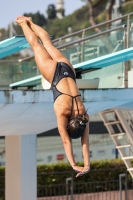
xmin=53 ymin=12 xmax=133 ymax=43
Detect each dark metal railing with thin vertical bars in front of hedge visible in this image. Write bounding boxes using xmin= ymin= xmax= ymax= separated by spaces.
xmin=38 ymin=174 xmax=133 ymax=200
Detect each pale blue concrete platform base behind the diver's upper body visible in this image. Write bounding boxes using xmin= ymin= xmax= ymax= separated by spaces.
xmin=0 ymin=88 xmax=133 ymax=136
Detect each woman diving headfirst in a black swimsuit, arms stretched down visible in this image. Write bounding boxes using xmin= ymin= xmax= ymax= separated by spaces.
xmin=15 ymin=16 xmax=90 ymax=177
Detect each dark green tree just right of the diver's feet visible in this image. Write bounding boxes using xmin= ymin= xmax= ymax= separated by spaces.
xmin=24 ymin=12 xmax=47 ymax=26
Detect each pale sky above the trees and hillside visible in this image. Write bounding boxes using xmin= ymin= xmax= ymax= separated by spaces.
xmin=0 ymin=0 xmax=85 ymax=28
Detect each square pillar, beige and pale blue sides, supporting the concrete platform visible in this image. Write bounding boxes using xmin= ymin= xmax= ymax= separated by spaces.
xmin=5 ymin=135 xmax=37 ymax=200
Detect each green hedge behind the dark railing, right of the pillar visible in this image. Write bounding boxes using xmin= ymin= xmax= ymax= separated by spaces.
xmin=37 ymin=159 xmax=131 ymax=196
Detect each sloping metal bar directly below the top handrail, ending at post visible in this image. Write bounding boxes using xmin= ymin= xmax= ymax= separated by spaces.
xmin=57 ymin=25 xmax=125 ymax=49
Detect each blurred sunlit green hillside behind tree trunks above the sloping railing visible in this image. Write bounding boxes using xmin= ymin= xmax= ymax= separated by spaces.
xmin=44 ymin=0 xmax=133 ymax=38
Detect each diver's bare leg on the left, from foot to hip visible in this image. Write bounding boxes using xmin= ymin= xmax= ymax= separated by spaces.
xmin=15 ymin=17 xmax=57 ymax=83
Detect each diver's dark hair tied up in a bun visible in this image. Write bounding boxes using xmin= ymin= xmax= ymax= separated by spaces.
xmin=67 ymin=115 xmax=88 ymax=139
